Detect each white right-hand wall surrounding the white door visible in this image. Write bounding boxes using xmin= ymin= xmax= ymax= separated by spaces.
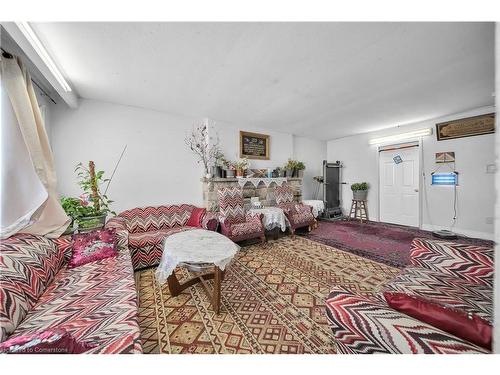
xmin=327 ymin=107 xmax=495 ymax=239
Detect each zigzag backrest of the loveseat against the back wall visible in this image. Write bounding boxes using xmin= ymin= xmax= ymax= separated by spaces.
xmin=117 ymin=204 xmax=195 ymax=233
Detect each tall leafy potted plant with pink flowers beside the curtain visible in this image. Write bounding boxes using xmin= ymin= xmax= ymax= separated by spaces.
xmin=75 ymin=161 xmax=116 ymax=232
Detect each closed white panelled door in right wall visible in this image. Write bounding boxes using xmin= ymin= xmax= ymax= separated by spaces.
xmin=379 ymin=146 xmax=420 ymax=227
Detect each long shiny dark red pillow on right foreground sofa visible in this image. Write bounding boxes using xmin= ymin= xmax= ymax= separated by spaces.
xmin=384 ymin=292 xmax=493 ymax=350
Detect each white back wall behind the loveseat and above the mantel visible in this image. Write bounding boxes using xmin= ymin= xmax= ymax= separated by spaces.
xmin=51 ymin=99 xmax=326 ymax=212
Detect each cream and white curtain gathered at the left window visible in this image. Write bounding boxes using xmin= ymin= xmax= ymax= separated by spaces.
xmin=0 ymin=57 xmax=70 ymax=238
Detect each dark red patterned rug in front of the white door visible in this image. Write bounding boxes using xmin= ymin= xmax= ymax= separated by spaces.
xmin=303 ymin=221 xmax=494 ymax=268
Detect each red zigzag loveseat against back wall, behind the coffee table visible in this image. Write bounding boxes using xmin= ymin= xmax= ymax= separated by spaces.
xmin=106 ymin=204 xmax=218 ymax=270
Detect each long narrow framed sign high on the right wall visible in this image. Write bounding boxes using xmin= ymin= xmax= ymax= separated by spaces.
xmin=436 ymin=113 xmax=495 ymax=141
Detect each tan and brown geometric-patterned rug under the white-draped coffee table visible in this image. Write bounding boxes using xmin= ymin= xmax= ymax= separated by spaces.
xmin=136 ymin=237 xmax=400 ymax=353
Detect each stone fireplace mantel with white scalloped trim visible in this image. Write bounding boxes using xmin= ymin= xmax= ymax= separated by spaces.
xmin=201 ymin=177 xmax=302 ymax=211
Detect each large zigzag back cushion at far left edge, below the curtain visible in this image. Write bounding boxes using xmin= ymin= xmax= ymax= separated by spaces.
xmin=0 ymin=234 xmax=64 ymax=341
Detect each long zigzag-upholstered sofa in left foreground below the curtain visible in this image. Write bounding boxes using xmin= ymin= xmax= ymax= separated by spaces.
xmin=0 ymin=234 xmax=142 ymax=353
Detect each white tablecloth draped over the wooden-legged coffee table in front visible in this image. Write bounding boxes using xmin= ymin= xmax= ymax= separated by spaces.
xmin=156 ymin=229 xmax=240 ymax=284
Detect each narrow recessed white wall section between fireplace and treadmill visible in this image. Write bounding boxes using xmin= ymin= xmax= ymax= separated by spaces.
xmin=293 ymin=136 xmax=326 ymax=199
